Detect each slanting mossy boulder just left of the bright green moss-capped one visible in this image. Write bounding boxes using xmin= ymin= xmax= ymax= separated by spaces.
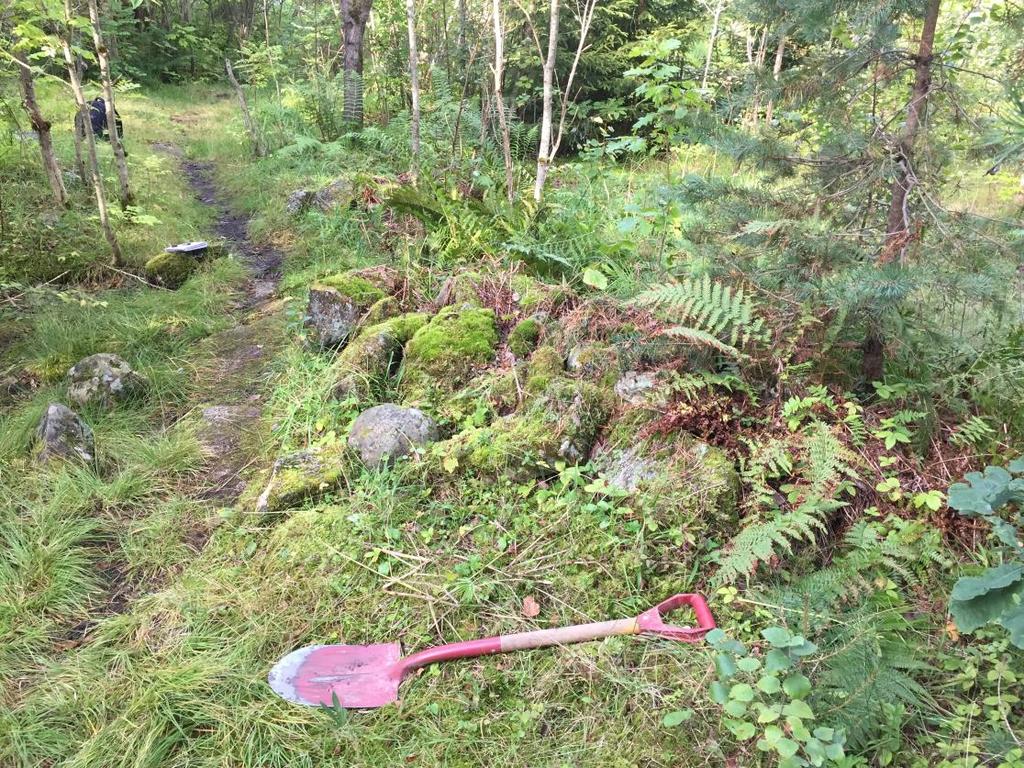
xmin=331 ymin=312 xmax=430 ymax=400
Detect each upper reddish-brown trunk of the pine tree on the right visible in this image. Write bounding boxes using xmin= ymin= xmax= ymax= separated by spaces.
xmin=878 ymin=0 xmax=941 ymax=265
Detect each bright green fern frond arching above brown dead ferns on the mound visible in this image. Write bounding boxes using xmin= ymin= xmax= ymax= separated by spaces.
xmin=634 ymin=275 xmax=766 ymax=357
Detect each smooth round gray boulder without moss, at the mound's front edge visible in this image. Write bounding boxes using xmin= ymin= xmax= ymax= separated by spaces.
xmin=348 ymin=402 xmax=437 ymax=467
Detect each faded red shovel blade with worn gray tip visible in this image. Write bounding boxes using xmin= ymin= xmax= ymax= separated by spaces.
xmin=267 ymin=643 xmax=402 ymax=710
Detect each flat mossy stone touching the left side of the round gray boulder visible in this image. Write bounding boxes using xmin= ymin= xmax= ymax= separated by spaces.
xmin=256 ymin=440 xmax=351 ymax=512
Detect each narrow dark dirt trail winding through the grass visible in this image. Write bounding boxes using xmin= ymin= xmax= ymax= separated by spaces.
xmin=159 ymin=145 xmax=285 ymax=504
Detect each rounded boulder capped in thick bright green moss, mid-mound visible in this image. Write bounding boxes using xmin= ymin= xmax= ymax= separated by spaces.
xmin=401 ymin=307 xmax=498 ymax=402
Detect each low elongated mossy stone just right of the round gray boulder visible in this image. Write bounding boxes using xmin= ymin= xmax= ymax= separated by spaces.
xmin=431 ymin=378 xmax=612 ymax=477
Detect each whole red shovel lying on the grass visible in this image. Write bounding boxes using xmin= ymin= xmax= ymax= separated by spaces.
xmin=268 ymin=595 xmax=715 ymax=710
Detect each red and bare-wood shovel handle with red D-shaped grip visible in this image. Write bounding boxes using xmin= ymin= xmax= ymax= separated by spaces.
xmin=401 ymin=595 xmax=715 ymax=673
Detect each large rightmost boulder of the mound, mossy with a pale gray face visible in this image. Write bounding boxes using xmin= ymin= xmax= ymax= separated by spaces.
xmin=593 ymin=409 xmax=739 ymax=544
